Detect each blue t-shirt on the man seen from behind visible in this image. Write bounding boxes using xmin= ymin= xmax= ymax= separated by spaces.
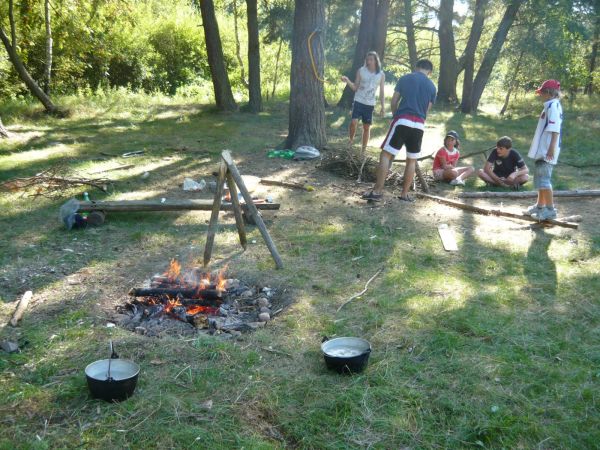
xmin=394 ymin=71 xmax=436 ymax=120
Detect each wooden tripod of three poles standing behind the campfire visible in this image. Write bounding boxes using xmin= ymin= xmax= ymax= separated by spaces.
xmin=204 ymin=150 xmax=283 ymax=269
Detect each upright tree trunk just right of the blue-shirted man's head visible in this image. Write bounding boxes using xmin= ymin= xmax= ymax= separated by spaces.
xmin=437 ymin=0 xmax=458 ymax=104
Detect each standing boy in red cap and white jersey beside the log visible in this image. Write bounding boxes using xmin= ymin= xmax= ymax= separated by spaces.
xmin=525 ymin=80 xmax=562 ymax=220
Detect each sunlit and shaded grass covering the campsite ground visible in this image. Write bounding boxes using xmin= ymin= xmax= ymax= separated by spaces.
xmin=0 ymin=89 xmax=600 ymax=449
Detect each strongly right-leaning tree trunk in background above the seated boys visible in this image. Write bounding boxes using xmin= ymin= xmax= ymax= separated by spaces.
xmin=465 ymin=0 xmax=525 ymax=113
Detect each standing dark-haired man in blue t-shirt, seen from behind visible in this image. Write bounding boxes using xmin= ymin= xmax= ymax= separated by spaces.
xmin=362 ymin=59 xmax=436 ymax=202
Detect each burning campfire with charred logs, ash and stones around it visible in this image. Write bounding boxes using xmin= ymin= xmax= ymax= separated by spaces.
xmin=117 ymin=260 xmax=283 ymax=336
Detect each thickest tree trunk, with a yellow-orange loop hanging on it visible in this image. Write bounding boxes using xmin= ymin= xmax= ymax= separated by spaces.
xmin=285 ymin=0 xmax=327 ymax=149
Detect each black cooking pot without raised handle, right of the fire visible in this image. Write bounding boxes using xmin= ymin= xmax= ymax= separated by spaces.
xmin=321 ymin=337 xmax=371 ymax=373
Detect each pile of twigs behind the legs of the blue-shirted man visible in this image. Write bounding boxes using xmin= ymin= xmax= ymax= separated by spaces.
xmin=318 ymin=148 xmax=435 ymax=191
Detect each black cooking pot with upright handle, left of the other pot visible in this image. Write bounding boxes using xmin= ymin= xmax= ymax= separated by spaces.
xmin=85 ymin=341 xmax=140 ymax=402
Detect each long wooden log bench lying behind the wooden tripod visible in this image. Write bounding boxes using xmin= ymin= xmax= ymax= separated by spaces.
xmin=78 ymin=199 xmax=281 ymax=212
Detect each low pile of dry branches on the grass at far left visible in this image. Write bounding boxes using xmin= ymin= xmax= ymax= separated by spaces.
xmin=0 ymin=165 xmax=112 ymax=197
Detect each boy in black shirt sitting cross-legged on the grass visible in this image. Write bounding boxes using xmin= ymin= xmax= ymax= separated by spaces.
xmin=477 ymin=136 xmax=529 ymax=191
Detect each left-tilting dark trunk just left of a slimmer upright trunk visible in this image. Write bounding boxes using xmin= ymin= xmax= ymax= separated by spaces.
xmin=200 ymin=0 xmax=237 ymax=111
